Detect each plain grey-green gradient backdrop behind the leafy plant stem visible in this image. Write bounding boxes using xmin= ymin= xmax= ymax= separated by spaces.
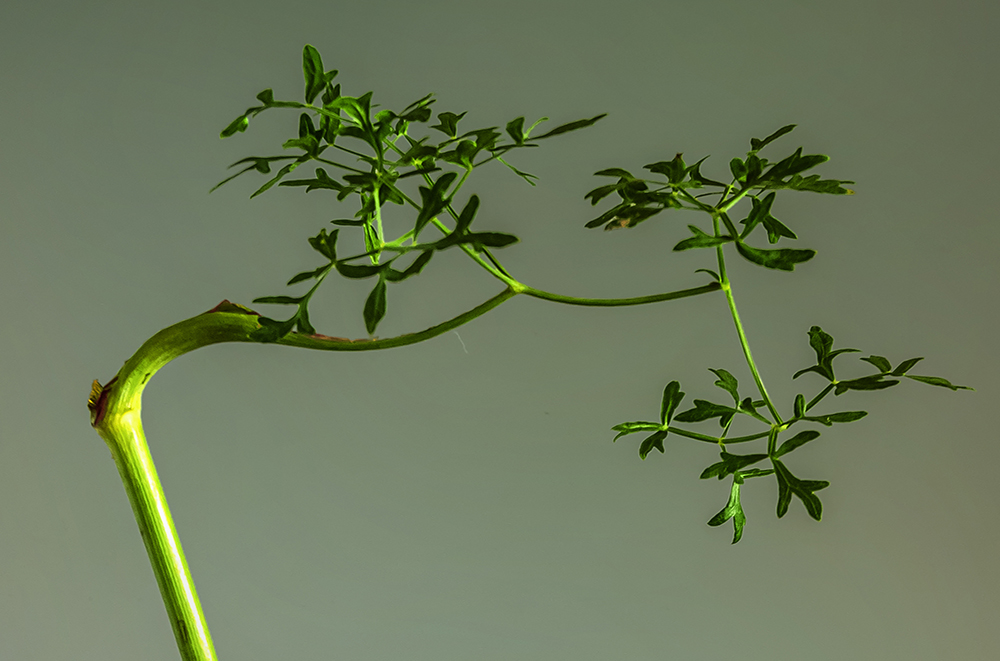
xmin=0 ymin=0 xmax=1000 ymax=661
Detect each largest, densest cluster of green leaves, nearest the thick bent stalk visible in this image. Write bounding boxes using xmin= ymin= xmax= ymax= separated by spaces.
xmin=210 ymin=44 xmax=605 ymax=342
